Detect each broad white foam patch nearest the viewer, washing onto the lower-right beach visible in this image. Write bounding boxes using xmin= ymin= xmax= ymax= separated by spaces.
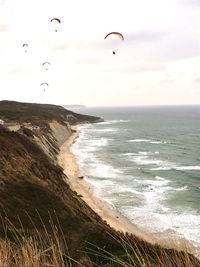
xmin=121 ymin=206 xmax=200 ymax=247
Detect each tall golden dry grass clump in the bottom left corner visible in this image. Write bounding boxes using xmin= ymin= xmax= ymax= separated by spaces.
xmin=0 ymin=217 xmax=78 ymax=267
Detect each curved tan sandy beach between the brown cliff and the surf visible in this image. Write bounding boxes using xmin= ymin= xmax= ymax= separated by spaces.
xmin=58 ymin=127 xmax=197 ymax=256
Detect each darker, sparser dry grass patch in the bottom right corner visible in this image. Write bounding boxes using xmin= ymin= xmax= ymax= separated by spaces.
xmin=87 ymin=233 xmax=200 ymax=267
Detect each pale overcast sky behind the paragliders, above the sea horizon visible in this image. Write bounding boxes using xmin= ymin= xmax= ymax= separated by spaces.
xmin=0 ymin=0 xmax=200 ymax=106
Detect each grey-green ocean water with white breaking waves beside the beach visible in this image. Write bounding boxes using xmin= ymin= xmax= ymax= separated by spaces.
xmin=72 ymin=106 xmax=200 ymax=251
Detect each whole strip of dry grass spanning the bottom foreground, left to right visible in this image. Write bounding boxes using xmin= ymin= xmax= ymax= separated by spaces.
xmin=0 ymin=214 xmax=200 ymax=267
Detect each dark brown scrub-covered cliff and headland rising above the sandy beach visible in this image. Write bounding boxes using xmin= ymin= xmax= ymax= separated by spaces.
xmin=0 ymin=101 xmax=200 ymax=267
